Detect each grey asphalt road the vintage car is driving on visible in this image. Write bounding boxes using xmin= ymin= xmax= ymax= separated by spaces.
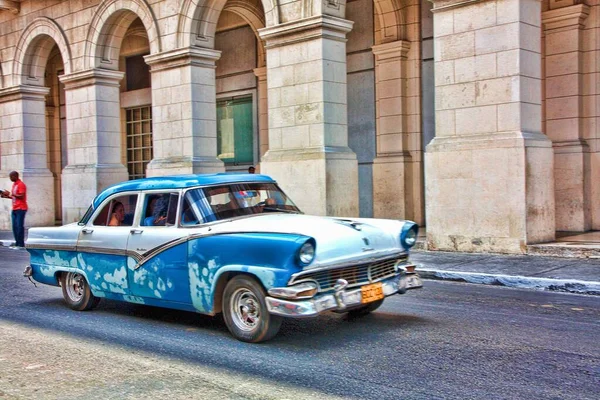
xmin=0 ymin=248 xmax=600 ymax=399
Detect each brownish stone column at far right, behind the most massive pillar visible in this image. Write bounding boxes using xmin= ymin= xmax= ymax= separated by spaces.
xmin=542 ymin=0 xmax=592 ymax=232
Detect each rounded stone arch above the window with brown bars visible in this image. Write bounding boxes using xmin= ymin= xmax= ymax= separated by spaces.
xmin=84 ymin=0 xmax=162 ymax=70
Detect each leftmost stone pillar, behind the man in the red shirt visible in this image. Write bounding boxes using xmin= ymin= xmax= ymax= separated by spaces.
xmin=0 ymin=85 xmax=54 ymax=229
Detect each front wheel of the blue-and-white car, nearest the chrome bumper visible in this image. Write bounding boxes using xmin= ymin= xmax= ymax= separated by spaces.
xmin=223 ymin=275 xmax=282 ymax=343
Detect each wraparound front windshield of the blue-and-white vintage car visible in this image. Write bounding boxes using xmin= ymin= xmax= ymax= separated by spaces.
xmin=181 ymin=183 xmax=300 ymax=225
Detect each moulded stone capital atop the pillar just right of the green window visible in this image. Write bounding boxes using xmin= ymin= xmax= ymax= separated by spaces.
xmin=258 ymin=15 xmax=354 ymax=48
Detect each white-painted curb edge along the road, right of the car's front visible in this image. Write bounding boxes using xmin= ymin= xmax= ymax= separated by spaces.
xmin=418 ymin=269 xmax=600 ymax=296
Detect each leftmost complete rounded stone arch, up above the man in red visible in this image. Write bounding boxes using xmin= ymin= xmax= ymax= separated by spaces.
xmin=13 ymin=17 xmax=73 ymax=86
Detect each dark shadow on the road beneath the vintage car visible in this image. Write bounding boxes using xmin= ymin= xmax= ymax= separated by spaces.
xmin=15 ymin=298 xmax=433 ymax=349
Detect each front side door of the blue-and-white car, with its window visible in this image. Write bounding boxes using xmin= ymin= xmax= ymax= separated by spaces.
xmin=127 ymin=191 xmax=191 ymax=304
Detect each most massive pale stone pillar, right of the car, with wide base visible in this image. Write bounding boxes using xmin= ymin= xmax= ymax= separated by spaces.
xmin=425 ymin=0 xmax=555 ymax=253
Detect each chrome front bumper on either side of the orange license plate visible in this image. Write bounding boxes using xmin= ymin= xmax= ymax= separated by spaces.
xmin=266 ymin=273 xmax=423 ymax=318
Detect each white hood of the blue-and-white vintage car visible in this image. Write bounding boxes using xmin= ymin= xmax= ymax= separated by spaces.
xmin=207 ymin=213 xmax=404 ymax=269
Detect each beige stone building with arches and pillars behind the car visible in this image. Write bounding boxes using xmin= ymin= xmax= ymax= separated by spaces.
xmin=0 ymin=0 xmax=600 ymax=253
